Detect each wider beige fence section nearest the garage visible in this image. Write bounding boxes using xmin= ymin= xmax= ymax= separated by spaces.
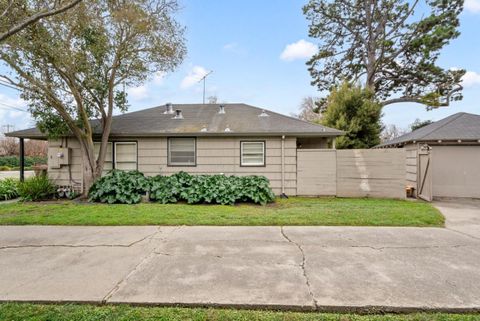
xmin=337 ymin=148 xmax=406 ymax=198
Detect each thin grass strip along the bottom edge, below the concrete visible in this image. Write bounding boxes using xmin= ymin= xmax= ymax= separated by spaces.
xmin=0 ymin=303 xmax=480 ymax=321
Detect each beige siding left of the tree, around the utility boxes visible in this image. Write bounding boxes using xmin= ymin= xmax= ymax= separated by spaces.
xmin=48 ymin=138 xmax=82 ymax=189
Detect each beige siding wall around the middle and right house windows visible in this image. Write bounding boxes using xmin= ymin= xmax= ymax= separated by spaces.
xmin=137 ymin=137 xmax=297 ymax=195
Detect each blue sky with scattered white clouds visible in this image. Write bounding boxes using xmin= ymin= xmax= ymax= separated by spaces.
xmin=0 ymin=0 xmax=480 ymax=129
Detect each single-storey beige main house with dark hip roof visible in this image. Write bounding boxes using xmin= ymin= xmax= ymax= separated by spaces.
xmin=9 ymin=104 xmax=343 ymax=195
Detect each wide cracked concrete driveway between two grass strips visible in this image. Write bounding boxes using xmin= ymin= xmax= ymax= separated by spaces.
xmin=0 ymin=202 xmax=480 ymax=311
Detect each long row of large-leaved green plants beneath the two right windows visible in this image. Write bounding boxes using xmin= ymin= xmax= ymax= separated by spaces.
xmin=150 ymin=172 xmax=275 ymax=204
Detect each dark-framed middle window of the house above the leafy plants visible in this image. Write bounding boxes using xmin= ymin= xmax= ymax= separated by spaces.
xmin=168 ymin=137 xmax=197 ymax=166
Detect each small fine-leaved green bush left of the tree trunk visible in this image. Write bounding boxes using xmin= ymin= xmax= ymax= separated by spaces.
xmin=18 ymin=175 xmax=56 ymax=201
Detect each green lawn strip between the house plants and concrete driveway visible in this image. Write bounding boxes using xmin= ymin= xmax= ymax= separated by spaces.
xmin=0 ymin=198 xmax=444 ymax=226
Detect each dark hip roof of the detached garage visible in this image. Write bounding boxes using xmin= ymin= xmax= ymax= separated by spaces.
xmin=376 ymin=113 xmax=480 ymax=147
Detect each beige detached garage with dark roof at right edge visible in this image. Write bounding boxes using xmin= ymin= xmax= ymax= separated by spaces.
xmin=377 ymin=113 xmax=480 ymax=201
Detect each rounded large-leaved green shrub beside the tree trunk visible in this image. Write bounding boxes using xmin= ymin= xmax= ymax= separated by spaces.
xmin=89 ymin=170 xmax=149 ymax=204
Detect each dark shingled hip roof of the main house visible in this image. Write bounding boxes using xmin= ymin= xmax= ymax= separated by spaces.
xmin=8 ymin=104 xmax=344 ymax=138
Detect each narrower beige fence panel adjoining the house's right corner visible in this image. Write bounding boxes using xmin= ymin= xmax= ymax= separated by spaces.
xmin=297 ymin=149 xmax=337 ymax=196
